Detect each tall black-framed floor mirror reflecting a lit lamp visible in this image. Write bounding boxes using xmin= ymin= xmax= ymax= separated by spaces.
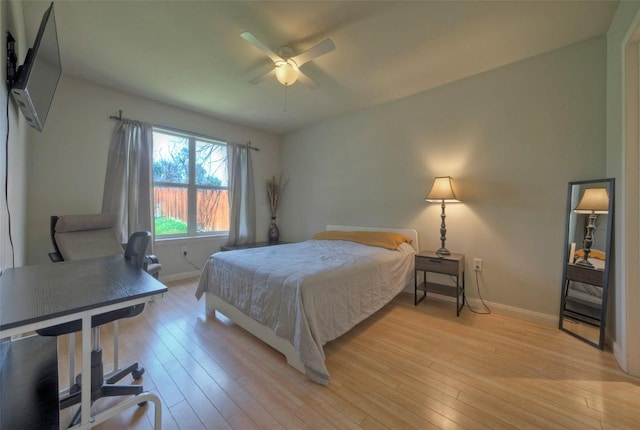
xmin=559 ymin=179 xmax=615 ymax=349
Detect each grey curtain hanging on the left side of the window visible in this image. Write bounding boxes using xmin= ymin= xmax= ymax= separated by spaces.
xmin=102 ymin=119 xmax=153 ymax=243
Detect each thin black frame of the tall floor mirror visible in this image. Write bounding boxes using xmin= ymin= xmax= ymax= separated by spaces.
xmin=558 ymin=178 xmax=615 ymax=349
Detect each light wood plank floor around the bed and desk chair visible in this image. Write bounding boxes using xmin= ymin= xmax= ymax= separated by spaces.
xmin=60 ymin=279 xmax=640 ymax=430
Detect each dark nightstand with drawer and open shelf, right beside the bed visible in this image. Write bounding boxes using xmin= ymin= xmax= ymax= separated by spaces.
xmin=414 ymin=251 xmax=465 ymax=316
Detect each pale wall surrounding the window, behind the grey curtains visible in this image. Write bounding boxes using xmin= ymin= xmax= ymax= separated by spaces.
xmin=27 ymin=75 xmax=279 ymax=279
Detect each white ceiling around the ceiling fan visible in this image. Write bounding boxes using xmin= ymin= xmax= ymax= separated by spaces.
xmin=24 ymin=0 xmax=617 ymax=133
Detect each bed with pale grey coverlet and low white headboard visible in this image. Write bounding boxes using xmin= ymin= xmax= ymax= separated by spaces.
xmin=196 ymin=225 xmax=418 ymax=385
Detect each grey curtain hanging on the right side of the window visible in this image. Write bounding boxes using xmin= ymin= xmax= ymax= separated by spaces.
xmin=227 ymin=143 xmax=256 ymax=246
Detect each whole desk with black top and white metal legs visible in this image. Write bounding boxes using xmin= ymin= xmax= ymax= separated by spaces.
xmin=0 ymin=255 xmax=167 ymax=429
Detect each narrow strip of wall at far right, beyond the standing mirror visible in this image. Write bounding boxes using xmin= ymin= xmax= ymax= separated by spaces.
xmin=607 ymin=2 xmax=640 ymax=376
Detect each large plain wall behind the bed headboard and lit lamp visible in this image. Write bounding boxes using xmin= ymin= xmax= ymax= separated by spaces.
xmin=279 ymin=38 xmax=606 ymax=323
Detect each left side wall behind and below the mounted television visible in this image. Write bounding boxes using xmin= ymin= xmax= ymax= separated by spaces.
xmin=0 ymin=1 xmax=29 ymax=272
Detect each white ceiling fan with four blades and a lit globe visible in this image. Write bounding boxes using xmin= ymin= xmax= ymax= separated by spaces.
xmin=240 ymin=31 xmax=336 ymax=90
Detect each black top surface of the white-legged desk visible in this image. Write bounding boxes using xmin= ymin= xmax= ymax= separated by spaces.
xmin=0 ymin=255 xmax=167 ymax=330
